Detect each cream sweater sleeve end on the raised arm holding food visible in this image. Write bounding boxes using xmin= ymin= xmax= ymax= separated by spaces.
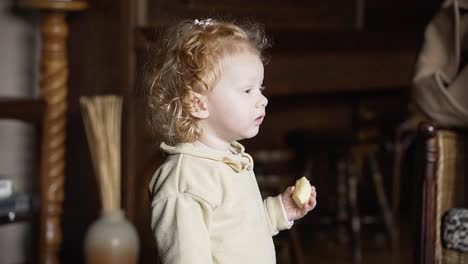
xmin=263 ymin=195 xmax=293 ymax=236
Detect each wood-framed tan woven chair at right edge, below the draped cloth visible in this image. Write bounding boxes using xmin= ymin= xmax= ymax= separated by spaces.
xmin=415 ymin=123 xmax=468 ymax=264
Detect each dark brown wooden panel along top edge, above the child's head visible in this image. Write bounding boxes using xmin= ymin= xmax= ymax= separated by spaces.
xmin=148 ymin=0 xmax=355 ymax=30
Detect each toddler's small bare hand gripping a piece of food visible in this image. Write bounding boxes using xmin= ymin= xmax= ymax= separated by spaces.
xmin=281 ymin=186 xmax=317 ymax=221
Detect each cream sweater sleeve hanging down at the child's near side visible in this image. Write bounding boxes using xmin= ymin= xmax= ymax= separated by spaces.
xmin=151 ymin=193 xmax=212 ymax=264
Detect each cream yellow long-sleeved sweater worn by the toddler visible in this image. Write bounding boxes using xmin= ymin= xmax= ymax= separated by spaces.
xmin=149 ymin=142 xmax=292 ymax=264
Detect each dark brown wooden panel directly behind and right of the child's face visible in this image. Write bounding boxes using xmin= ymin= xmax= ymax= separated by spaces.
xmin=265 ymin=51 xmax=416 ymax=96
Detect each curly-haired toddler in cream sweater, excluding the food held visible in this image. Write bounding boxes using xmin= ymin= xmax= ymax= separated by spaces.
xmin=147 ymin=19 xmax=316 ymax=264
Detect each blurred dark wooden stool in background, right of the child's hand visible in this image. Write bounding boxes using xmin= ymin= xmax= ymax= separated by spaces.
xmin=287 ymin=131 xmax=398 ymax=263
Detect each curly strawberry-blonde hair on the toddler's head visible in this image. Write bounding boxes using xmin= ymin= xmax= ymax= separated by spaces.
xmin=145 ymin=20 xmax=270 ymax=145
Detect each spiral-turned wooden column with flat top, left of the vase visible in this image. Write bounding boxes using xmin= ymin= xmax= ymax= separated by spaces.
xmin=19 ymin=0 xmax=87 ymax=264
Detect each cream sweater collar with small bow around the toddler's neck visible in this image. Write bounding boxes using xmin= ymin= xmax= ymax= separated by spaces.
xmin=160 ymin=141 xmax=253 ymax=172
